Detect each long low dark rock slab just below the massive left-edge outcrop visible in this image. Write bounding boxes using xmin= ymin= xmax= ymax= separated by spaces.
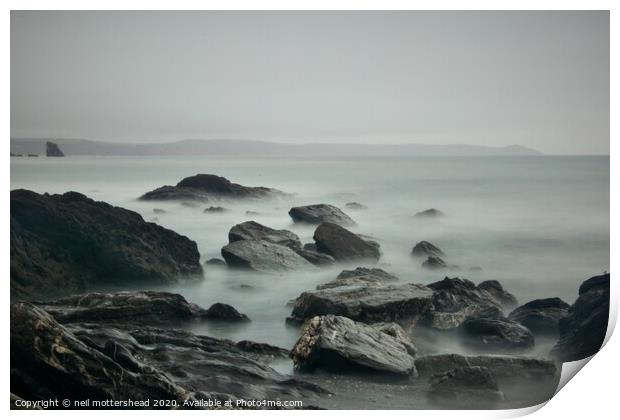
xmin=37 ymin=291 xmax=205 ymax=325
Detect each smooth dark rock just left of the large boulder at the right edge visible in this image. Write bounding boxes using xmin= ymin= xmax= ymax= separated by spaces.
xmin=508 ymin=298 xmax=570 ymax=335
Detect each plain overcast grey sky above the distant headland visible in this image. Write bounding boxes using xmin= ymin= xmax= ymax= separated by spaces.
xmin=11 ymin=11 xmax=609 ymax=154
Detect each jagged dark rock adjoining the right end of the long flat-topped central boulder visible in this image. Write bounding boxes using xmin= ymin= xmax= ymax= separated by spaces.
xmin=425 ymin=277 xmax=503 ymax=330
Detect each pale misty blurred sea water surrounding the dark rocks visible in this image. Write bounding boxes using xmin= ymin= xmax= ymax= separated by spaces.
xmin=11 ymin=156 xmax=609 ymax=406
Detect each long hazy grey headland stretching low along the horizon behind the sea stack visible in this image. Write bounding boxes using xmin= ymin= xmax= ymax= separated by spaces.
xmin=11 ymin=139 xmax=541 ymax=157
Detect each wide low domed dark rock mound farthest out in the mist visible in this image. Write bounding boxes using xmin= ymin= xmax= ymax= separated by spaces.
xmin=139 ymin=174 xmax=287 ymax=201
